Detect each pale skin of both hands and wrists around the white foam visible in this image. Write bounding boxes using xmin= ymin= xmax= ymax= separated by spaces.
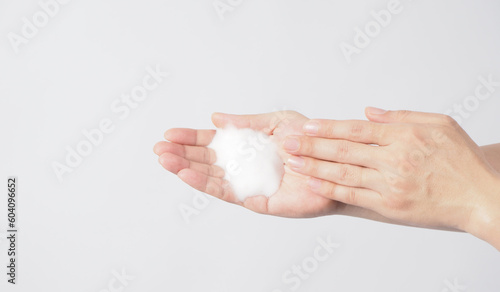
xmin=154 ymin=108 xmax=500 ymax=250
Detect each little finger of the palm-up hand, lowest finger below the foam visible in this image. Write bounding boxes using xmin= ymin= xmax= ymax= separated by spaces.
xmin=177 ymin=168 xmax=241 ymax=205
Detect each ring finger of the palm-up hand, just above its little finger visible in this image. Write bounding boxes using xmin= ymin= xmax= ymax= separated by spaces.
xmin=159 ymin=152 xmax=224 ymax=177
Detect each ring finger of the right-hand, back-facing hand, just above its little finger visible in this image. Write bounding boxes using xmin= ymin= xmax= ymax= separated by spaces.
xmin=287 ymin=156 xmax=383 ymax=189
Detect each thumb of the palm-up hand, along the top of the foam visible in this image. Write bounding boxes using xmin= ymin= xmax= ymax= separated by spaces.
xmin=212 ymin=111 xmax=290 ymax=134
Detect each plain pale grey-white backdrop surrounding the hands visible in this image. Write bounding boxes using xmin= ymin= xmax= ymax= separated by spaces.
xmin=0 ymin=0 xmax=500 ymax=292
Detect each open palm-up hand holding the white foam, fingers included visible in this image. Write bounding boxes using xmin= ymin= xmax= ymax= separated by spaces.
xmin=155 ymin=111 xmax=339 ymax=217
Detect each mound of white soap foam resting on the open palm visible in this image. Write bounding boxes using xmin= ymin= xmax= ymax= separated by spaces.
xmin=208 ymin=125 xmax=284 ymax=201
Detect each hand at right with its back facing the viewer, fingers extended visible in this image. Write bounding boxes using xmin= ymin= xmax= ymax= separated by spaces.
xmin=284 ymin=108 xmax=500 ymax=248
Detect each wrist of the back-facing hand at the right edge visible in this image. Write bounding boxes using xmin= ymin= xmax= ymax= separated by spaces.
xmin=464 ymin=173 xmax=500 ymax=251
